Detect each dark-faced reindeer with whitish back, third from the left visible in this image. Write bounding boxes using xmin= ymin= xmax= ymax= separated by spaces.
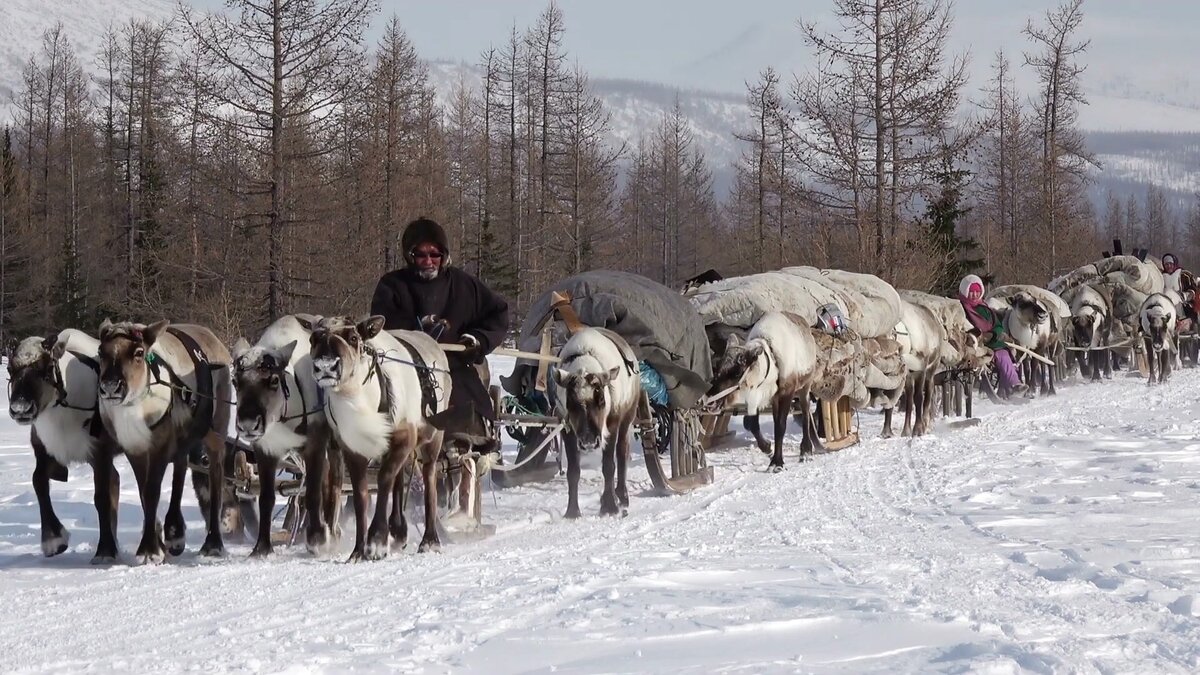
xmin=233 ymin=315 xmax=342 ymax=557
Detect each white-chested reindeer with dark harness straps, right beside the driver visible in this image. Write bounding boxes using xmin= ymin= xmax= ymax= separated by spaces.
xmin=299 ymin=316 xmax=450 ymax=562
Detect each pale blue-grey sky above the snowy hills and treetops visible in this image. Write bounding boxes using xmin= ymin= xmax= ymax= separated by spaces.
xmin=184 ymin=0 xmax=1200 ymax=101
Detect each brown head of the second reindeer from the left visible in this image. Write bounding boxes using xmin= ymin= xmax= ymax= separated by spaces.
xmin=100 ymin=318 xmax=170 ymax=405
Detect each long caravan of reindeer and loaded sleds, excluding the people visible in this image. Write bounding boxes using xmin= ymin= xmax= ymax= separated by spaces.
xmin=8 ymin=247 xmax=1194 ymax=563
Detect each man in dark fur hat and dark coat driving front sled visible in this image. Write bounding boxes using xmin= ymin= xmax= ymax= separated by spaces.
xmin=371 ymin=217 xmax=509 ymax=460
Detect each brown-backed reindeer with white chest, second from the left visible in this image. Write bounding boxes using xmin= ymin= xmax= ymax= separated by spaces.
xmin=98 ymin=319 xmax=234 ymax=565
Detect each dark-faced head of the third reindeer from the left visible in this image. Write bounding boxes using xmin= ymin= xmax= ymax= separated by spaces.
xmin=233 ymin=339 xmax=296 ymax=443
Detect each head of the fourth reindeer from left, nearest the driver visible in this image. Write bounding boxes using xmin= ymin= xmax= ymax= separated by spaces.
xmin=300 ymin=315 xmax=384 ymax=389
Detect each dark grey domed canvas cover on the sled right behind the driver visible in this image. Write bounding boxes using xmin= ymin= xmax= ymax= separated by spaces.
xmin=502 ymin=270 xmax=713 ymax=408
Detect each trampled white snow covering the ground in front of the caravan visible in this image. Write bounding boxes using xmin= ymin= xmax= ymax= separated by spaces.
xmin=0 ymin=355 xmax=1200 ymax=674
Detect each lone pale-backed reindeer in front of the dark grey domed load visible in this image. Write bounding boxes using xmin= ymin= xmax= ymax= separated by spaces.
xmin=553 ymin=327 xmax=649 ymax=519
